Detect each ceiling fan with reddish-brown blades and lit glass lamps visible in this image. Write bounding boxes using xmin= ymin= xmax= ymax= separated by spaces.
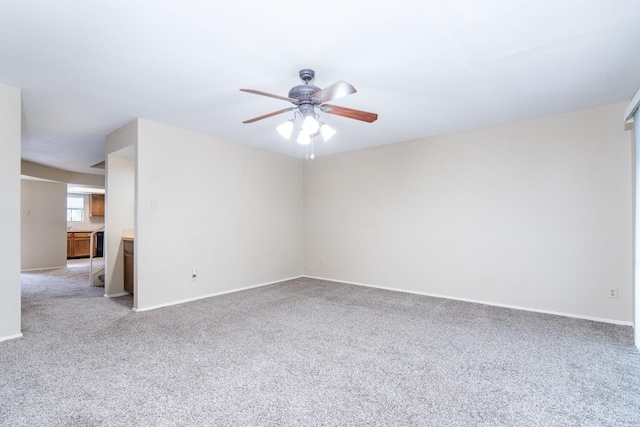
xmin=240 ymin=69 xmax=378 ymax=159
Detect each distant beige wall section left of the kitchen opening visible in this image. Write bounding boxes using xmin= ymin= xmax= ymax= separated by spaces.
xmin=20 ymin=179 xmax=67 ymax=270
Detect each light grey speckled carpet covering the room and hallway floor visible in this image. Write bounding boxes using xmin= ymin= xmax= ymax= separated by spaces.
xmin=0 ymin=266 xmax=640 ymax=426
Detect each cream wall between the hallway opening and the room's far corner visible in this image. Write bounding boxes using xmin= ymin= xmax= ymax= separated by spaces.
xmin=135 ymin=120 xmax=302 ymax=310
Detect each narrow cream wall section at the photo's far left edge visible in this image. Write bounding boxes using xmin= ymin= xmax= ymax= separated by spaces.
xmin=0 ymin=84 xmax=22 ymax=341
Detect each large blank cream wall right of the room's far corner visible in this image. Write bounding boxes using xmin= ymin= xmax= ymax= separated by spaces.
xmin=304 ymin=103 xmax=632 ymax=323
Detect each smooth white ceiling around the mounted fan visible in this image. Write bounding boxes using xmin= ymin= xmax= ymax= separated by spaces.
xmin=0 ymin=0 xmax=640 ymax=174
